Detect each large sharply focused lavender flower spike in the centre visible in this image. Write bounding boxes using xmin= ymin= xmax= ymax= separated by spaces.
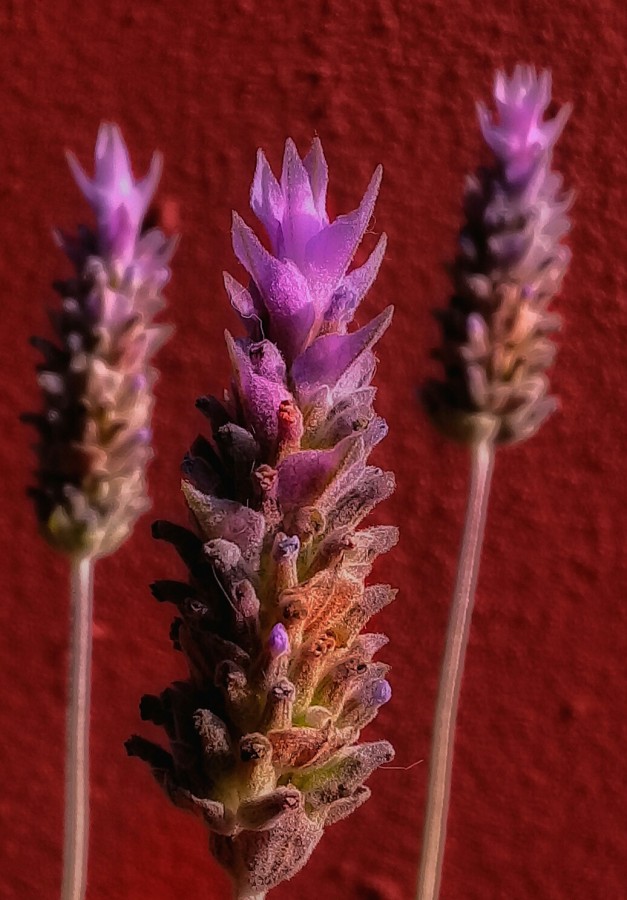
xmin=127 ymin=140 xmax=397 ymax=898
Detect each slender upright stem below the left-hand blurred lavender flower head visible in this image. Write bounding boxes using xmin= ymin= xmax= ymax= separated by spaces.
xmin=61 ymin=557 xmax=94 ymax=900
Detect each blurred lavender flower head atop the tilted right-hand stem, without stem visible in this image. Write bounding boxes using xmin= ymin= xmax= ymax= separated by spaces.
xmin=424 ymin=66 xmax=572 ymax=443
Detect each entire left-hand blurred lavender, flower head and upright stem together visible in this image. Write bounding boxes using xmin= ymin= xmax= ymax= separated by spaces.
xmin=24 ymin=124 xmax=174 ymax=900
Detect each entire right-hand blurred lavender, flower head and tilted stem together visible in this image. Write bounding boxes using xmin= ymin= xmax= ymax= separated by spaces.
xmin=417 ymin=66 xmax=572 ymax=900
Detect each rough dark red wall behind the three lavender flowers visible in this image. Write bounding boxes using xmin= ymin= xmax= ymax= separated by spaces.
xmin=0 ymin=0 xmax=627 ymax=900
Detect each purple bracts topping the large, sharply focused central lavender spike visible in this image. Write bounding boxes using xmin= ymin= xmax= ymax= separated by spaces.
xmin=229 ymin=138 xmax=385 ymax=362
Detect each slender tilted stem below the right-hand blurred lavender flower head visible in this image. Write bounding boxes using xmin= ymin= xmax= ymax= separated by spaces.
xmin=416 ymin=441 xmax=494 ymax=900
